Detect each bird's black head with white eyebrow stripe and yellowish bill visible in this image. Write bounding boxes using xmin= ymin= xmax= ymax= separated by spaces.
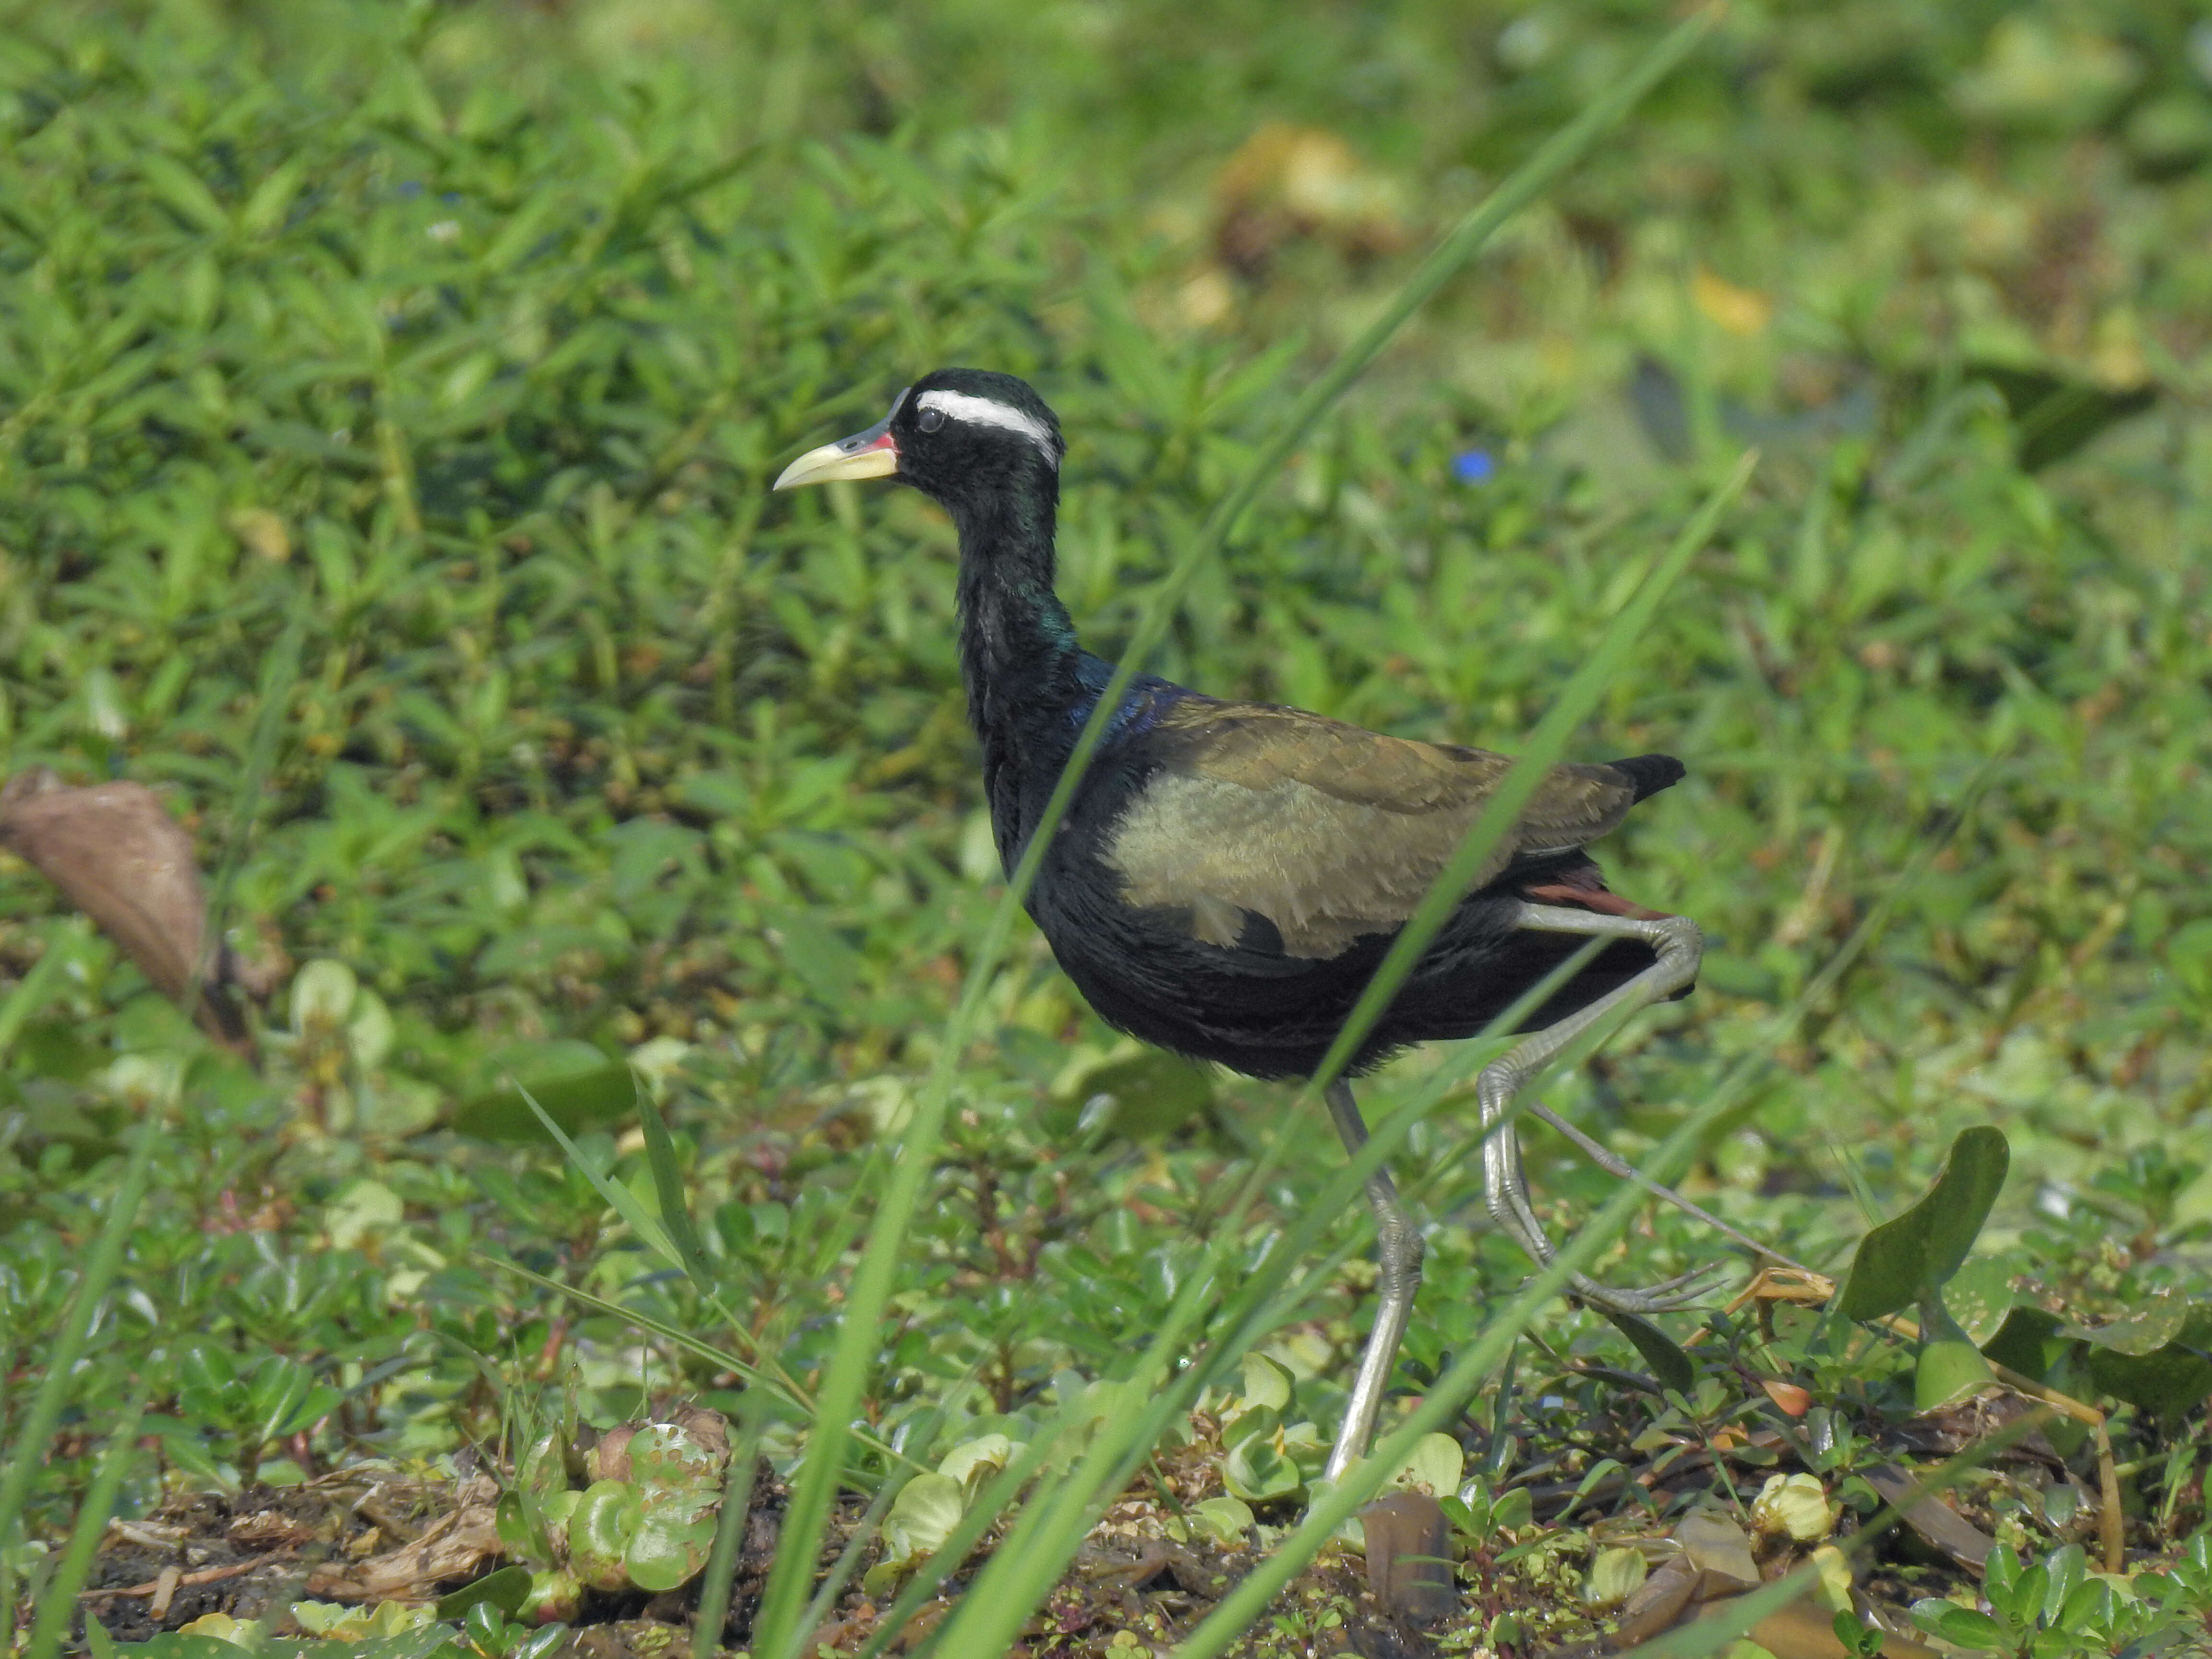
xmin=776 ymin=370 xmax=1066 ymax=506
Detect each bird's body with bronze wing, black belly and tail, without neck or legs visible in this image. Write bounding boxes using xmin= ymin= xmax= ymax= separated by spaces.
xmin=1002 ymin=679 xmax=1683 ymax=1077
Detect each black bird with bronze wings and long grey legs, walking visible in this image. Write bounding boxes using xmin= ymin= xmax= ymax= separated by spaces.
xmin=774 ymin=367 xmax=1703 ymax=1480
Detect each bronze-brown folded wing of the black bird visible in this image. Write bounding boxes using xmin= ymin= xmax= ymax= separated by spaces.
xmin=1106 ymin=697 xmax=1637 ymax=958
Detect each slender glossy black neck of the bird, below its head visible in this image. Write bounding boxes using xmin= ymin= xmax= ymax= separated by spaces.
xmin=947 ymin=487 xmax=1082 ymax=752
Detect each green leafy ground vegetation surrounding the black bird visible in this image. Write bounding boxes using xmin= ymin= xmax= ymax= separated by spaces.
xmin=0 ymin=0 xmax=2212 ymax=1659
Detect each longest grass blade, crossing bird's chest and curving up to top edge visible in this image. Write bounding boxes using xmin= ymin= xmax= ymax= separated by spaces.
xmin=754 ymin=7 xmax=1721 ymax=1659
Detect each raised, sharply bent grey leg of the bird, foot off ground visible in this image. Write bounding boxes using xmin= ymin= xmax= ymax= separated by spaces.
xmin=1476 ymin=905 xmax=1706 ymax=1314
